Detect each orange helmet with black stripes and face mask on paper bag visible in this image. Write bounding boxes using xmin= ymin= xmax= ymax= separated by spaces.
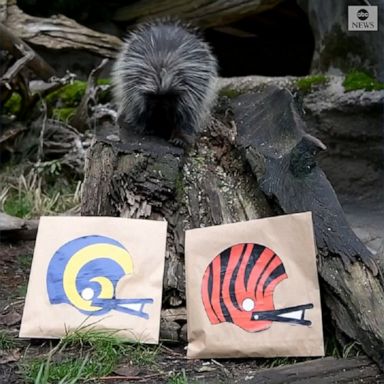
xmin=201 ymin=243 xmax=313 ymax=332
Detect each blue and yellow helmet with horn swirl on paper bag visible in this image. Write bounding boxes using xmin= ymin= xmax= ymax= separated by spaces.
xmin=47 ymin=235 xmax=153 ymax=319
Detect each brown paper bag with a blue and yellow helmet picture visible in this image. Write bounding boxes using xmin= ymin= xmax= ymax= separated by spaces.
xmin=20 ymin=217 xmax=167 ymax=344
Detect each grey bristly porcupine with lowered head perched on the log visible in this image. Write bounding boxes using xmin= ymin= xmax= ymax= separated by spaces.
xmin=112 ymin=19 xmax=217 ymax=146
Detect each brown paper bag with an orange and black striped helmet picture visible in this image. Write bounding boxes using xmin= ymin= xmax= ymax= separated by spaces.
xmin=185 ymin=213 xmax=324 ymax=358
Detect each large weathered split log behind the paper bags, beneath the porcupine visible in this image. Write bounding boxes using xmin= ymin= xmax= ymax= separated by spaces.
xmin=82 ymin=85 xmax=384 ymax=367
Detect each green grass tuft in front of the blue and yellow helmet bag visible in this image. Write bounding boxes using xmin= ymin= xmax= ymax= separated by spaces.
xmin=21 ymin=329 xmax=158 ymax=384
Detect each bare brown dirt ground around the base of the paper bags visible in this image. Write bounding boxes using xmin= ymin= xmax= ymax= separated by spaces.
xmin=0 ymin=241 xmax=303 ymax=384
